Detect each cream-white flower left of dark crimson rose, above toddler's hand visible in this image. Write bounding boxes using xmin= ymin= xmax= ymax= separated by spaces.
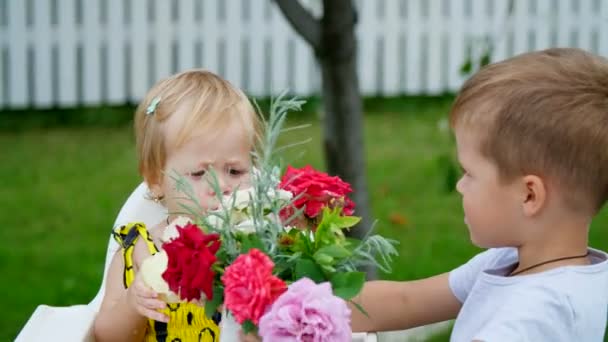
xmin=139 ymin=250 xmax=180 ymax=303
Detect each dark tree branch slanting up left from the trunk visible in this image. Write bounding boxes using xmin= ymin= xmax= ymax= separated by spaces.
xmin=274 ymin=0 xmax=321 ymax=50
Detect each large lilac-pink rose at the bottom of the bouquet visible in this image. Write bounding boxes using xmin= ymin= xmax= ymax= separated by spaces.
xmin=258 ymin=278 xmax=352 ymax=342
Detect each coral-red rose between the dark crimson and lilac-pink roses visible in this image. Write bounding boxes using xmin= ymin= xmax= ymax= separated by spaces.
xmin=222 ymin=248 xmax=287 ymax=325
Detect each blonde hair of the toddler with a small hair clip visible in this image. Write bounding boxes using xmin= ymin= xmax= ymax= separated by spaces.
xmin=134 ymin=69 xmax=261 ymax=184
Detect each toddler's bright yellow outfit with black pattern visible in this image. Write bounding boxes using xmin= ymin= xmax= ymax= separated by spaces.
xmin=113 ymin=223 xmax=221 ymax=342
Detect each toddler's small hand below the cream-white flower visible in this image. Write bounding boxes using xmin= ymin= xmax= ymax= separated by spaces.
xmin=127 ymin=274 xmax=169 ymax=323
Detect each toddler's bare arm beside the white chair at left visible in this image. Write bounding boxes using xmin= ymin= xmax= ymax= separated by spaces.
xmin=94 ymin=250 xmax=146 ymax=342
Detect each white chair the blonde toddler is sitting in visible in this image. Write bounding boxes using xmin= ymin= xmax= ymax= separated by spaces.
xmin=15 ymin=183 xmax=377 ymax=342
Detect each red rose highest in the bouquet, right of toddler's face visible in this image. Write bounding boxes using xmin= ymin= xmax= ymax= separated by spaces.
xmin=279 ymin=165 xmax=355 ymax=219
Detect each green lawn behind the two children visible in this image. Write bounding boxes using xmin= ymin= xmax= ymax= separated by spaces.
xmin=0 ymin=98 xmax=608 ymax=341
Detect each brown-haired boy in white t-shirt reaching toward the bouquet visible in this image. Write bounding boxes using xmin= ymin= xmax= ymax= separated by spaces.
xmin=352 ymin=49 xmax=608 ymax=342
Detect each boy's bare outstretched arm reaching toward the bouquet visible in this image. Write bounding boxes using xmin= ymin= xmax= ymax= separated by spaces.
xmin=349 ymin=273 xmax=462 ymax=332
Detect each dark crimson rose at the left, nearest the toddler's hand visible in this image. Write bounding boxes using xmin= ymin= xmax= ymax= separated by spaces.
xmin=163 ymin=223 xmax=221 ymax=301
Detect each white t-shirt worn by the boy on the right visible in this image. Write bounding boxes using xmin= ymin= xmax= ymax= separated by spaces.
xmin=449 ymin=248 xmax=608 ymax=342
